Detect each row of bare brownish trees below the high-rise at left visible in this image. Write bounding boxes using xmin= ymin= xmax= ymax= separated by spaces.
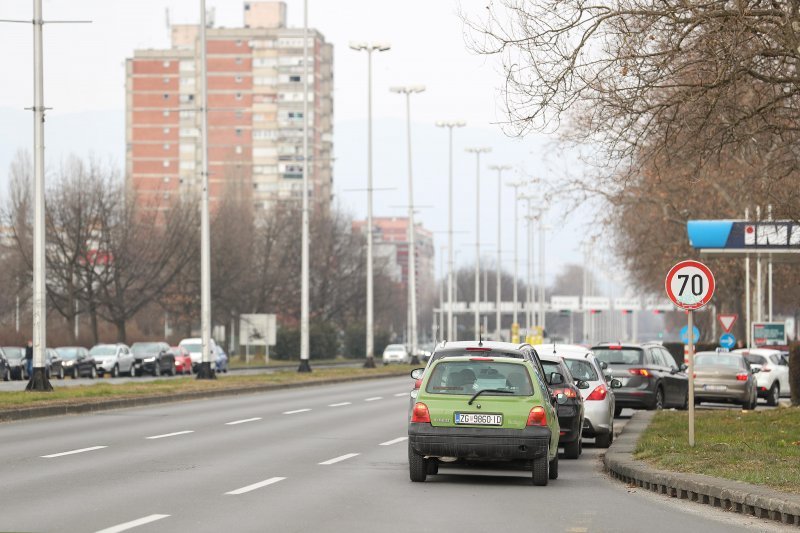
xmin=0 ymin=155 xmax=406 ymax=355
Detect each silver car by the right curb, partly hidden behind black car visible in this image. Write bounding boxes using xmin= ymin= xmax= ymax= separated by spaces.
xmin=535 ymin=344 xmax=621 ymax=448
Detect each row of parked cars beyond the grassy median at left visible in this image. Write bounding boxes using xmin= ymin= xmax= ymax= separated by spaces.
xmin=0 ymin=338 xmax=228 ymax=381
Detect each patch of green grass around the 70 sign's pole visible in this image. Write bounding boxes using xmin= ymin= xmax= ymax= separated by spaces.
xmin=635 ymin=407 xmax=800 ymax=493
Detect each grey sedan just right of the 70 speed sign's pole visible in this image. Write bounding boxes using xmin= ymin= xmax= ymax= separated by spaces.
xmin=694 ymin=352 xmax=758 ymax=410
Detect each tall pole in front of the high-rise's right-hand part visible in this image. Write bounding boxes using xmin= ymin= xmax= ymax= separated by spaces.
xmin=297 ymin=0 xmax=310 ymax=372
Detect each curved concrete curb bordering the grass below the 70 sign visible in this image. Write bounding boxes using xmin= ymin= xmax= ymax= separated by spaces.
xmin=603 ymin=411 xmax=800 ymax=526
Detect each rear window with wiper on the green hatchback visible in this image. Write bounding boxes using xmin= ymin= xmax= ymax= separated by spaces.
xmin=425 ymin=361 xmax=533 ymax=396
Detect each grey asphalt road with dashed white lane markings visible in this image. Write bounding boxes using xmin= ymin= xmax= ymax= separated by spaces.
xmin=0 ymin=378 xmax=789 ymax=533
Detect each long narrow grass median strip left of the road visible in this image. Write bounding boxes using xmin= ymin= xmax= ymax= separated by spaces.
xmin=0 ymin=363 xmax=412 ymax=410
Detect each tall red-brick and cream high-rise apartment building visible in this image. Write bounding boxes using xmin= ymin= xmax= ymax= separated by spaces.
xmin=126 ymin=2 xmax=333 ymax=210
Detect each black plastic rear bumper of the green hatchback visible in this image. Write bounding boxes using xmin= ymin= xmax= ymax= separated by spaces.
xmin=408 ymin=422 xmax=550 ymax=461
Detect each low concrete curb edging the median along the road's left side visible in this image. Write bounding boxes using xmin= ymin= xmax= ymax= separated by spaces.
xmin=0 ymin=374 xmax=411 ymax=422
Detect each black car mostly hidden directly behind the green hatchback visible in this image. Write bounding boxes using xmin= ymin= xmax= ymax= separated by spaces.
xmin=539 ymin=354 xmax=589 ymax=459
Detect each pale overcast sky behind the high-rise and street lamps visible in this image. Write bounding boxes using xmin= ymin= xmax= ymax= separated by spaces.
xmin=0 ymin=0 xmax=616 ymax=290
